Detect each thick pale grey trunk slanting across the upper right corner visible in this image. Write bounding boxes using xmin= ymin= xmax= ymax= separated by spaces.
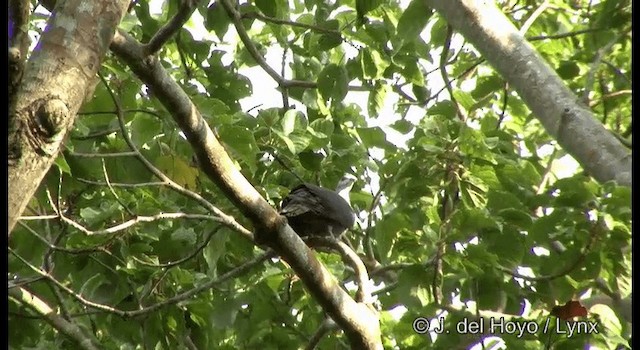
xmin=425 ymin=0 xmax=631 ymax=186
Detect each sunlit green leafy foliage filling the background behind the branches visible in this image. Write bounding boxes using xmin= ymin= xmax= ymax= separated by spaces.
xmin=9 ymin=0 xmax=631 ymax=349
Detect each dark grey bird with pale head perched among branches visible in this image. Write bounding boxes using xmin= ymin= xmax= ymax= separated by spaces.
xmin=280 ymin=174 xmax=356 ymax=238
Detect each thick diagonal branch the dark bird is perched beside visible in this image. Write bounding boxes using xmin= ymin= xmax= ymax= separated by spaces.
xmin=111 ymin=31 xmax=382 ymax=349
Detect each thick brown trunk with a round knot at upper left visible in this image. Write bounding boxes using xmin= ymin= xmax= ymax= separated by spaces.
xmin=7 ymin=0 xmax=130 ymax=235
